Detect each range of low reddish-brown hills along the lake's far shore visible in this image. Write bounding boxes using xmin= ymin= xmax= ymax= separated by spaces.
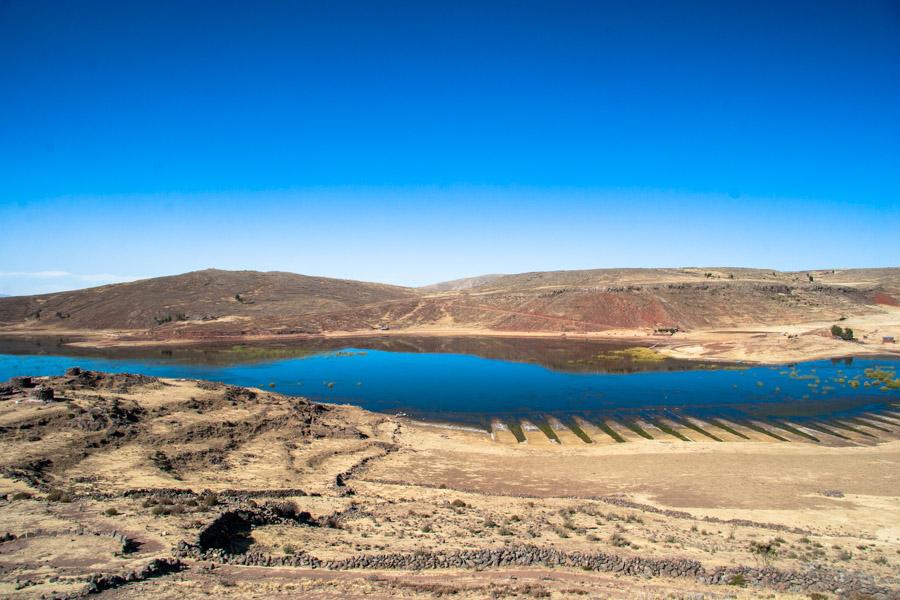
xmin=0 ymin=268 xmax=900 ymax=339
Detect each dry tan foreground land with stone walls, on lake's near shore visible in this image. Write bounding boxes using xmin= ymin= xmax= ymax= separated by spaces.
xmin=0 ymin=371 xmax=900 ymax=599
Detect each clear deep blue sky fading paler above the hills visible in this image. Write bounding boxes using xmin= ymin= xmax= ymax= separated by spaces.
xmin=0 ymin=0 xmax=900 ymax=294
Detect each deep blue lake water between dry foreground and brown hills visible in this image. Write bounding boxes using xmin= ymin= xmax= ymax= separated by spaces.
xmin=0 ymin=338 xmax=900 ymax=427
